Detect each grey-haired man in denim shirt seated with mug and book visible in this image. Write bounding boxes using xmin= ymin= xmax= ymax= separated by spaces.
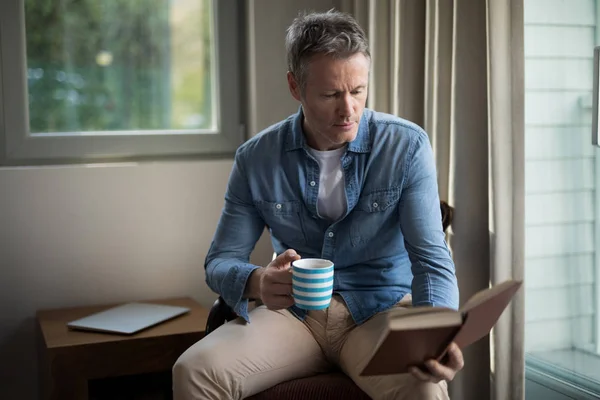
xmin=173 ymin=11 xmax=463 ymax=400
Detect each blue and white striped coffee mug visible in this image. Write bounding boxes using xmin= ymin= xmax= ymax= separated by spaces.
xmin=292 ymin=258 xmax=333 ymax=310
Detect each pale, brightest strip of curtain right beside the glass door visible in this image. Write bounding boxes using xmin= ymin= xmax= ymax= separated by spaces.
xmin=488 ymin=0 xmax=525 ymax=399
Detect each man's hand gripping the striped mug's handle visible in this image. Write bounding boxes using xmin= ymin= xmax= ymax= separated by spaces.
xmin=248 ymin=250 xmax=300 ymax=310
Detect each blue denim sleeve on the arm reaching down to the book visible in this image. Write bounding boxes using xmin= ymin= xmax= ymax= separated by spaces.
xmin=400 ymin=131 xmax=459 ymax=309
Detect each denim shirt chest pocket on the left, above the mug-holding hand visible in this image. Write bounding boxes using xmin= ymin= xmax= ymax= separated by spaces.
xmin=255 ymin=201 xmax=306 ymax=248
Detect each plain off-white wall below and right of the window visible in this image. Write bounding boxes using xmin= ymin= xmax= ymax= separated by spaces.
xmin=0 ymin=0 xmax=338 ymax=400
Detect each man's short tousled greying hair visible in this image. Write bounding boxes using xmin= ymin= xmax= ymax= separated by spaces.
xmin=285 ymin=10 xmax=371 ymax=92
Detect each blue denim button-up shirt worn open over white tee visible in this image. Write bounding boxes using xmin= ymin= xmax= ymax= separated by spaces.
xmin=205 ymin=108 xmax=459 ymax=324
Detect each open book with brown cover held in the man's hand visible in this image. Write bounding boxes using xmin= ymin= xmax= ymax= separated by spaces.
xmin=361 ymin=280 xmax=522 ymax=376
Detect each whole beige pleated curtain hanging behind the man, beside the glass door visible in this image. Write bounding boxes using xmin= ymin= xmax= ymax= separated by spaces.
xmin=345 ymin=0 xmax=524 ymax=400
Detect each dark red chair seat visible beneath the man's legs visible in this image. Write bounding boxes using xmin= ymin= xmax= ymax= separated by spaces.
xmin=248 ymin=372 xmax=370 ymax=400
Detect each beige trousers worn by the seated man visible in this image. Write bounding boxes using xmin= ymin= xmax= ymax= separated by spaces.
xmin=173 ymin=295 xmax=448 ymax=400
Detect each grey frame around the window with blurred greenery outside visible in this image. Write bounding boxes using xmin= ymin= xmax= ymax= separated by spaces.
xmin=0 ymin=0 xmax=246 ymax=166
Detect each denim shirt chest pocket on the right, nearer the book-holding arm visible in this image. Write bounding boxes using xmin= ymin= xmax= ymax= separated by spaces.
xmin=350 ymin=188 xmax=400 ymax=246
